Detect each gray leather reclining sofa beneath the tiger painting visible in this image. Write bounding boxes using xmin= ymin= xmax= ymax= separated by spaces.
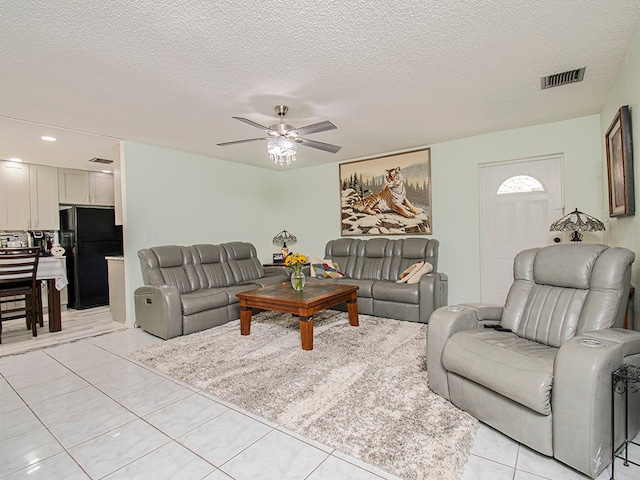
xmin=310 ymin=238 xmax=448 ymax=323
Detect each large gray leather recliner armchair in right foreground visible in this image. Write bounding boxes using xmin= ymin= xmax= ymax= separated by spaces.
xmin=427 ymin=244 xmax=640 ymax=477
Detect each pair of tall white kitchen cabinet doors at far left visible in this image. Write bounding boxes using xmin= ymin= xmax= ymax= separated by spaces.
xmin=0 ymin=161 xmax=60 ymax=230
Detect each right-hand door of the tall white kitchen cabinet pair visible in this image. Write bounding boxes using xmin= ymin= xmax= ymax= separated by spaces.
xmin=29 ymin=165 xmax=60 ymax=230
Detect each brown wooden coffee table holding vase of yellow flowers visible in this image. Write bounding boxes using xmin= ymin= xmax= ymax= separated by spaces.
xmin=236 ymin=282 xmax=358 ymax=350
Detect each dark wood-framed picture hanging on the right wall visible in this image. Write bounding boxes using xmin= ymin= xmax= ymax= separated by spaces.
xmin=605 ymin=105 xmax=636 ymax=217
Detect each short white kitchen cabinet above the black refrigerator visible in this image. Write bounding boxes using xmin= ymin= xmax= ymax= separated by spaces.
xmin=58 ymin=168 xmax=114 ymax=206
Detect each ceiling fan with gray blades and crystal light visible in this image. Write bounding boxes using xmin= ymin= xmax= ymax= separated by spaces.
xmin=218 ymin=105 xmax=342 ymax=165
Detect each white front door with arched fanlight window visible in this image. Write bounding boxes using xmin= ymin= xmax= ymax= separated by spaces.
xmin=480 ymin=155 xmax=563 ymax=305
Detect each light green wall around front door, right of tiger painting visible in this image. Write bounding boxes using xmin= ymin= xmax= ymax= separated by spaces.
xmin=431 ymin=115 xmax=602 ymax=303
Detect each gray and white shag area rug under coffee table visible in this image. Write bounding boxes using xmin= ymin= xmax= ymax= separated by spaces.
xmin=132 ymin=310 xmax=477 ymax=480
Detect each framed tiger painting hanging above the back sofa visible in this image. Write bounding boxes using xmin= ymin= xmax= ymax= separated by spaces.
xmin=340 ymin=148 xmax=433 ymax=236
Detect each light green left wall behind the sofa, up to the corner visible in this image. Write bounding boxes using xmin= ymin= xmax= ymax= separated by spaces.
xmin=121 ymin=142 xmax=286 ymax=325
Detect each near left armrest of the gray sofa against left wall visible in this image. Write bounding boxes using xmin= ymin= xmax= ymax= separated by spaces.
xmin=134 ymin=285 xmax=182 ymax=340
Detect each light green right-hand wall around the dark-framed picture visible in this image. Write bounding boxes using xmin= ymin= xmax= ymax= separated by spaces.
xmin=600 ymin=16 xmax=640 ymax=330
